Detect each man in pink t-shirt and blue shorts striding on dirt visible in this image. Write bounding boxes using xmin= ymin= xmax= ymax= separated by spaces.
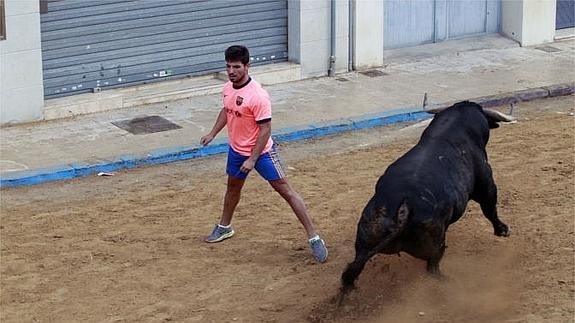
xmin=200 ymin=46 xmax=328 ymax=262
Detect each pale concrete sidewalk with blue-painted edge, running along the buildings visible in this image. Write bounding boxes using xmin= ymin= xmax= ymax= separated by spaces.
xmin=0 ymin=36 xmax=575 ymax=188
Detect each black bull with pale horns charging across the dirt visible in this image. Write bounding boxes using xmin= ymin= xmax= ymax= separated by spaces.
xmin=341 ymin=101 xmax=512 ymax=292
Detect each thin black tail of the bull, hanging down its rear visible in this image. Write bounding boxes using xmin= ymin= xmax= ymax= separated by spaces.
xmin=341 ymin=201 xmax=409 ymax=294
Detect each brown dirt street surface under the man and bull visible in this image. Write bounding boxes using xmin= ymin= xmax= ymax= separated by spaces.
xmin=0 ymin=96 xmax=575 ymax=323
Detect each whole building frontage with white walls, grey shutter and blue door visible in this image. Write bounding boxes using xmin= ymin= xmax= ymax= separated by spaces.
xmin=0 ymin=0 xmax=573 ymax=125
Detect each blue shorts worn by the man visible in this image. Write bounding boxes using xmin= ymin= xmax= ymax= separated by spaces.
xmin=226 ymin=145 xmax=286 ymax=181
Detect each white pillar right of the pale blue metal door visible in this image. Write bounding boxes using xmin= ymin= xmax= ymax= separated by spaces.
xmin=501 ymin=0 xmax=556 ymax=46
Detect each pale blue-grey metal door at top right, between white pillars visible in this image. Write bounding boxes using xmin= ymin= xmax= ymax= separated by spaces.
xmin=383 ymin=0 xmax=501 ymax=49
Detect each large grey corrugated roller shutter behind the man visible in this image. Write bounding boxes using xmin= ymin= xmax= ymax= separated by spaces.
xmin=41 ymin=0 xmax=287 ymax=97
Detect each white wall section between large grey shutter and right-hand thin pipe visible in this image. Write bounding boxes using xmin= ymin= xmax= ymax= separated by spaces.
xmin=288 ymin=0 xmax=349 ymax=78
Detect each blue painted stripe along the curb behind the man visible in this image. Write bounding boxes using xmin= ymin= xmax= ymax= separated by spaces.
xmin=0 ymin=109 xmax=430 ymax=188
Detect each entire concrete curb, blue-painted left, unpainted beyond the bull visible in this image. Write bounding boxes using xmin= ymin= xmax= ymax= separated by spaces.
xmin=0 ymin=83 xmax=575 ymax=188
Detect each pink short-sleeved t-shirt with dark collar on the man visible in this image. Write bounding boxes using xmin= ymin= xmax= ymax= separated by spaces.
xmin=223 ymin=80 xmax=273 ymax=156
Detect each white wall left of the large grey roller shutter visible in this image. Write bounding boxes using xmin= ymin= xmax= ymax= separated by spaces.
xmin=0 ymin=0 xmax=44 ymax=124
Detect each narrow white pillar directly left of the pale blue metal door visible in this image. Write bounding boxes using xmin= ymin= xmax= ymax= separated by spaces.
xmin=352 ymin=0 xmax=383 ymax=70
